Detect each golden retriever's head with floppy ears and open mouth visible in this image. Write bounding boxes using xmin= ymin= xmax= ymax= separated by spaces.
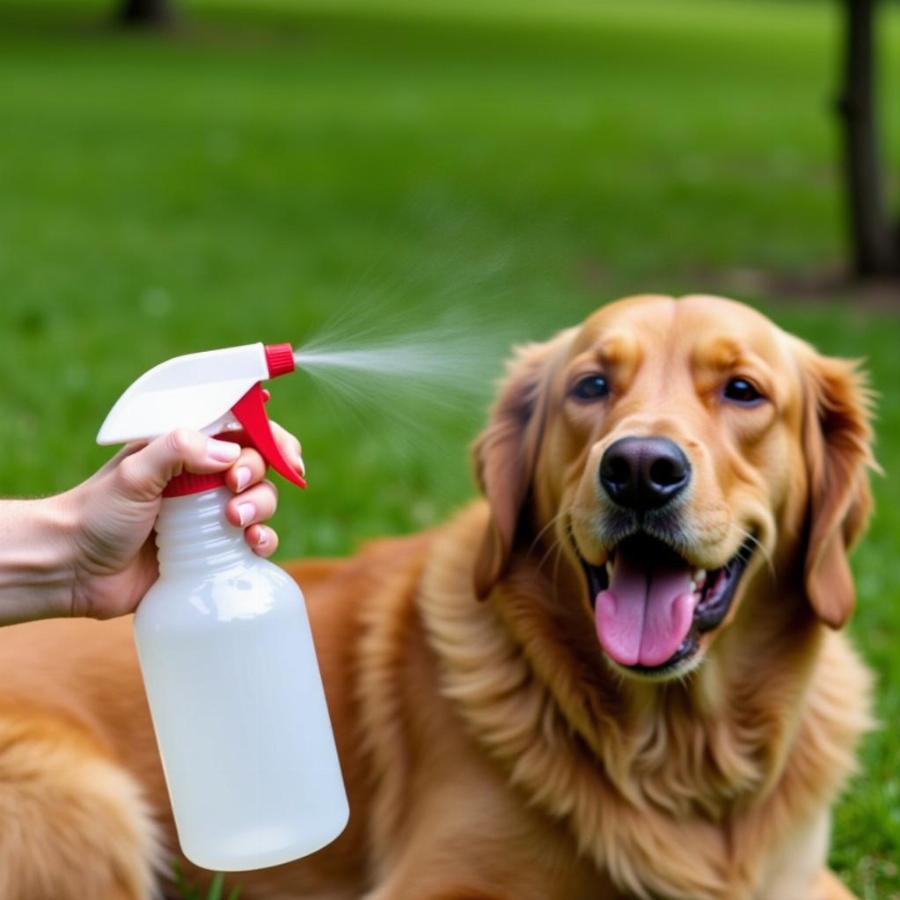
xmin=475 ymin=296 xmax=872 ymax=679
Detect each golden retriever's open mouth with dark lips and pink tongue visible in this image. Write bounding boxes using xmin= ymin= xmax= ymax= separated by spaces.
xmin=584 ymin=534 xmax=754 ymax=674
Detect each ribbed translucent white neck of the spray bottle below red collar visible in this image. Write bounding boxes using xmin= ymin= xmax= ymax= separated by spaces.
xmin=156 ymin=488 xmax=251 ymax=576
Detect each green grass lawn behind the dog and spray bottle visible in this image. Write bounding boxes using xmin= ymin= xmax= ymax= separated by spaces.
xmin=0 ymin=0 xmax=900 ymax=898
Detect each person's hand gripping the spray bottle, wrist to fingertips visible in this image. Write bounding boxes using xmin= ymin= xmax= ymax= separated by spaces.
xmin=60 ymin=424 xmax=303 ymax=619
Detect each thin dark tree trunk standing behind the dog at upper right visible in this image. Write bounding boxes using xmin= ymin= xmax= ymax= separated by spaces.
xmin=837 ymin=0 xmax=900 ymax=277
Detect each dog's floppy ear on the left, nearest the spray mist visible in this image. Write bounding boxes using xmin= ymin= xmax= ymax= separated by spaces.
xmin=472 ymin=340 xmax=556 ymax=600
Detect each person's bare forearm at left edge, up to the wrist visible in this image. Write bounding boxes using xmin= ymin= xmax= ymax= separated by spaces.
xmin=0 ymin=497 xmax=74 ymax=625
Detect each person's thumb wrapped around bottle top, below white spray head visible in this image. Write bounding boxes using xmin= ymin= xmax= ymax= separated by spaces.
xmin=119 ymin=428 xmax=241 ymax=500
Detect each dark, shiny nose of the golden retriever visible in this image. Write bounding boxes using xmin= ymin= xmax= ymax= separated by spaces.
xmin=600 ymin=437 xmax=691 ymax=512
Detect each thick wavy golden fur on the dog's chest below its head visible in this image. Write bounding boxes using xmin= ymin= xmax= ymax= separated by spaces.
xmin=376 ymin=507 xmax=868 ymax=900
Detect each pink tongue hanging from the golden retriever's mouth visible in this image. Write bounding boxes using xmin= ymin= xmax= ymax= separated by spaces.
xmin=595 ymin=553 xmax=697 ymax=666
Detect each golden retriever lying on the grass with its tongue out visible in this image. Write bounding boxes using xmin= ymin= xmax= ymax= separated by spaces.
xmin=0 ymin=296 xmax=874 ymax=900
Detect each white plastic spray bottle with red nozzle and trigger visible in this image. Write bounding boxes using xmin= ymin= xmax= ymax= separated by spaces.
xmin=97 ymin=344 xmax=349 ymax=871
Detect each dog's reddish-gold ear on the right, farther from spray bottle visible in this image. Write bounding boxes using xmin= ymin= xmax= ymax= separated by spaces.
xmin=802 ymin=347 xmax=876 ymax=628
